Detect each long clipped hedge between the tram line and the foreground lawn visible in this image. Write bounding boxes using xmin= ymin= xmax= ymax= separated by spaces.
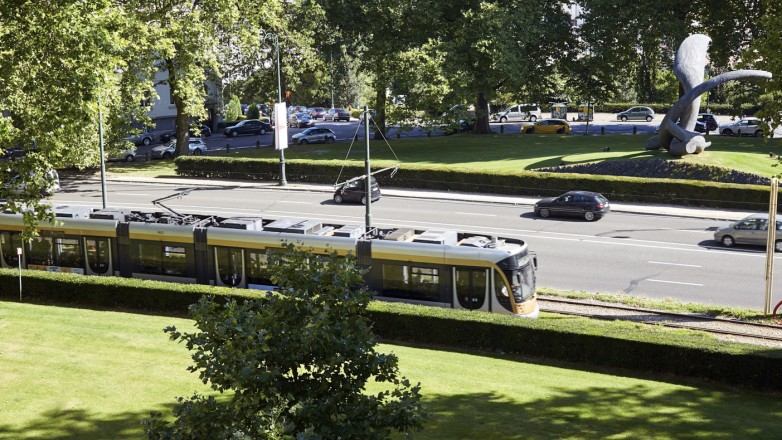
xmin=0 ymin=269 xmax=782 ymax=390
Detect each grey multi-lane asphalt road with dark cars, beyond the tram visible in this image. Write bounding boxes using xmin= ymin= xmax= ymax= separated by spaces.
xmin=54 ymin=180 xmax=782 ymax=310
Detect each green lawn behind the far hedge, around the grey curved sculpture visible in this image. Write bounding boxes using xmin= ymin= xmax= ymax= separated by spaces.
xmin=110 ymin=134 xmax=782 ymax=180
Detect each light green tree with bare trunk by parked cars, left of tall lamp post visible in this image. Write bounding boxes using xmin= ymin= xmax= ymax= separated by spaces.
xmin=124 ymin=0 xmax=282 ymax=155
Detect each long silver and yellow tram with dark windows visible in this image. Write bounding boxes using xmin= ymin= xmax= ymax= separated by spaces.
xmin=0 ymin=206 xmax=538 ymax=317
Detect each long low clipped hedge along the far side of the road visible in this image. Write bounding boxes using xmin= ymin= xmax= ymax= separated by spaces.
xmin=175 ymin=156 xmax=768 ymax=210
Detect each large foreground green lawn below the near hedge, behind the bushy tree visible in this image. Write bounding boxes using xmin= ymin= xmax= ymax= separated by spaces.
xmin=0 ymin=302 xmax=782 ymax=439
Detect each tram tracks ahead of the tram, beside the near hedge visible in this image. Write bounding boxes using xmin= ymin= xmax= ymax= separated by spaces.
xmin=538 ymin=296 xmax=782 ymax=347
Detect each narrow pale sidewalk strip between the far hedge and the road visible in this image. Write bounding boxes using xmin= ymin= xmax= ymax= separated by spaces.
xmin=98 ymin=175 xmax=752 ymax=221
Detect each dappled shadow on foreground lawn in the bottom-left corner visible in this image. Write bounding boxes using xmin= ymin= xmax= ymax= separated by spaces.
xmin=0 ymin=404 xmax=175 ymax=440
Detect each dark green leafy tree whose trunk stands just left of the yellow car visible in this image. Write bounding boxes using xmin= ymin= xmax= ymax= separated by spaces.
xmin=439 ymin=0 xmax=571 ymax=134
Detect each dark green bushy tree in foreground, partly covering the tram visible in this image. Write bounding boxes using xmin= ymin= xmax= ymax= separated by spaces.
xmin=144 ymin=244 xmax=422 ymax=439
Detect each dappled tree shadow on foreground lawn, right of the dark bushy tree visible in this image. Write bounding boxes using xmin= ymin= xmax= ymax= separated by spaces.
xmin=417 ymin=384 xmax=782 ymax=439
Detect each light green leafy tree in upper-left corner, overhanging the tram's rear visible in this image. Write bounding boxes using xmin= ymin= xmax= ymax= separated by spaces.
xmin=0 ymin=0 xmax=152 ymax=235
